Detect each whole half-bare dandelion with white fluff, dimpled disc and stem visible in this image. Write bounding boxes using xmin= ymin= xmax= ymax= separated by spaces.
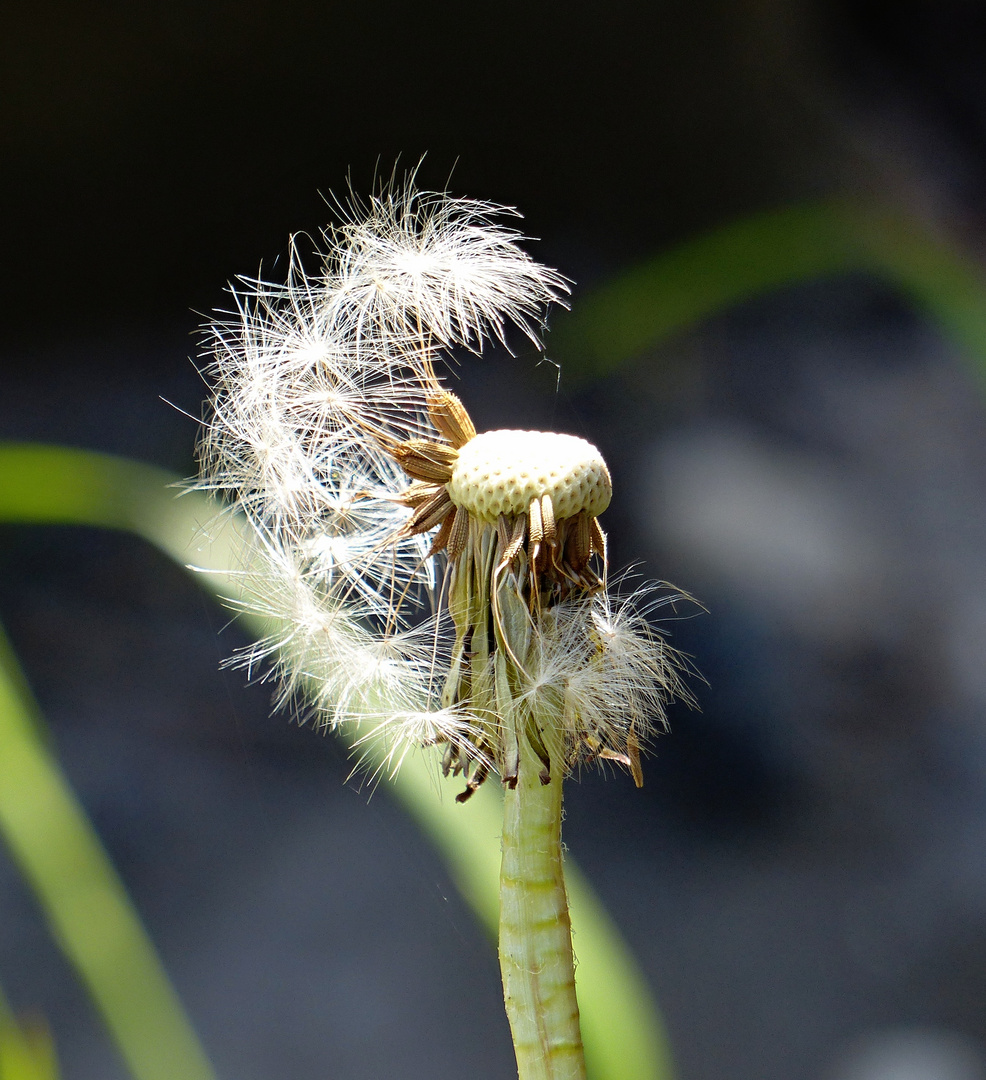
xmin=199 ymin=174 xmax=686 ymax=1080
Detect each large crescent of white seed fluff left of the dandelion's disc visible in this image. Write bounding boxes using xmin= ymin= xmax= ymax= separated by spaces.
xmin=192 ymin=181 xmax=568 ymax=767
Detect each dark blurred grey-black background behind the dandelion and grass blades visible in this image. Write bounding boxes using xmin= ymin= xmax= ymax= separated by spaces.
xmin=0 ymin=0 xmax=986 ymax=1080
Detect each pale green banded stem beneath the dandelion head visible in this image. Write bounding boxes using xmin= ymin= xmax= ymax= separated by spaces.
xmin=500 ymin=717 xmax=585 ymax=1080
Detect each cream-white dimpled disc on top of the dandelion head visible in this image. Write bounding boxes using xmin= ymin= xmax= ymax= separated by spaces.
xmin=447 ymin=431 xmax=612 ymax=522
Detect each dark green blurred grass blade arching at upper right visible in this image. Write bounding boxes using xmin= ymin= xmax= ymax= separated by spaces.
xmin=552 ymin=200 xmax=986 ymax=375
